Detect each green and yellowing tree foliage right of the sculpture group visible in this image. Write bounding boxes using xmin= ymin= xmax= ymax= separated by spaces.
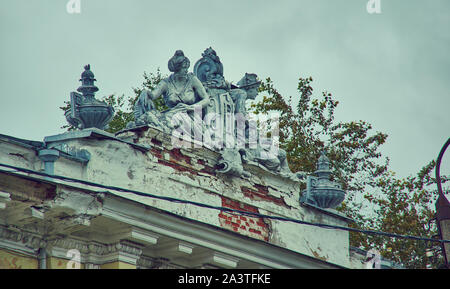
xmin=252 ymin=77 xmax=447 ymax=268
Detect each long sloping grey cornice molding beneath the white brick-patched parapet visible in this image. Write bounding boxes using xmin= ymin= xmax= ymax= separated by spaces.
xmin=102 ymin=195 xmax=342 ymax=269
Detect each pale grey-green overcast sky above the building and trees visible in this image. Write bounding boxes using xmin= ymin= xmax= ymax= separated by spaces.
xmin=0 ymin=0 xmax=450 ymax=176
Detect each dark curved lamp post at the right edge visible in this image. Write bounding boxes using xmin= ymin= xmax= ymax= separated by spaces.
xmin=436 ymin=138 xmax=450 ymax=269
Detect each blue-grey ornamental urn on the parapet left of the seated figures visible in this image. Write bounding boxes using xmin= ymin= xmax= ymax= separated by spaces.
xmin=65 ymin=64 xmax=114 ymax=130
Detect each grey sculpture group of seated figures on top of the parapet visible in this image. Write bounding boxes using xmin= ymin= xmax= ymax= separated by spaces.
xmin=127 ymin=48 xmax=304 ymax=178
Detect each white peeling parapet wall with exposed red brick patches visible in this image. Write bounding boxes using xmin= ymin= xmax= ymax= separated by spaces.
xmin=0 ymin=128 xmax=350 ymax=267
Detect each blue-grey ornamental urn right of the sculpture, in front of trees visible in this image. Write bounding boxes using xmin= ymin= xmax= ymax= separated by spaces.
xmin=300 ymin=152 xmax=345 ymax=208
